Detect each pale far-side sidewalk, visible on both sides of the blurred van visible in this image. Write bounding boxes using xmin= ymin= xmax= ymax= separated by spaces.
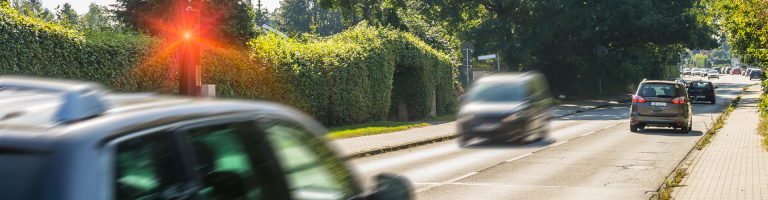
xmin=331 ymin=95 xmax=632 ymax=157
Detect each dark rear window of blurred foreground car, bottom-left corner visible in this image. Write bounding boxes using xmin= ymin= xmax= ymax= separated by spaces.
xmin=0 ymin=149 xmax=45 ymax=200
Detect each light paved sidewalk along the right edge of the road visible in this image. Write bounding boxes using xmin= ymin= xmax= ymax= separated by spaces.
xmin=672 ymin=85 xmax=768 ymax=200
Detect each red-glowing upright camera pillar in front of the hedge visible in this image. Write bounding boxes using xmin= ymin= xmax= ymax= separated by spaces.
xmin=179 ymin=7 xmax=201 ymax=96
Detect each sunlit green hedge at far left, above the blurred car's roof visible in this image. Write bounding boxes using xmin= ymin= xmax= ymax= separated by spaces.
xmin=0 ymin=4 xmax=153 ymax=83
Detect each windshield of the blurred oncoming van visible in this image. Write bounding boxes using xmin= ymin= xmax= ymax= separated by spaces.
xmin=465 ymin=83 xmax=525 ymax=102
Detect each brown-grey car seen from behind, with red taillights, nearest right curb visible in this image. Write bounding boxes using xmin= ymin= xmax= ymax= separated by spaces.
xmin=629 ymin=80 xmax=693 ymax=133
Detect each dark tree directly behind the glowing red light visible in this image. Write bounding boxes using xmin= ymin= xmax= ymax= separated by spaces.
xmin=111 ymin=0 xmax=256 ymax=44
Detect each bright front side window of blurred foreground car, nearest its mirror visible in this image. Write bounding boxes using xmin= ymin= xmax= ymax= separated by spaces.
xmin=262 ymin=120 xmax=355 ymax=199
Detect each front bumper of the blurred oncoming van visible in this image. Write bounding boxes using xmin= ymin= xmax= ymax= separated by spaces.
xmin=457 ymin=118 xmax=525 ymax=138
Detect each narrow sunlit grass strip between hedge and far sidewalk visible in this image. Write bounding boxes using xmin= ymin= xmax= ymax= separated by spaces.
xmin=325 ymin=121 xmax=430 ymax=140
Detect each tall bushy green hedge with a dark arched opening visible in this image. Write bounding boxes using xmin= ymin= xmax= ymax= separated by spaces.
xmin=250 ymin=25 xmax=455 ymax=125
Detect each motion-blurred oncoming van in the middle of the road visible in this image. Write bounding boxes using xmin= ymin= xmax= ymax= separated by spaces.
xmin=456 ymin=72 xmax=552 ymax=146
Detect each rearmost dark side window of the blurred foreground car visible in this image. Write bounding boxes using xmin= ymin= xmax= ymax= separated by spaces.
xmin=115 ymin=132 xmax=183 ymax=200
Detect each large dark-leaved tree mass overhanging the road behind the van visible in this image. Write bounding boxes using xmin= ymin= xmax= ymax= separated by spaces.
xmin=422 ymin=0 xmax=717 ymax=95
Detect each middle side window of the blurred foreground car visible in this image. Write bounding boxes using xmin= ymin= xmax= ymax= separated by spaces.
xmin=177 ymin=115 xmax=290 ymax=200
